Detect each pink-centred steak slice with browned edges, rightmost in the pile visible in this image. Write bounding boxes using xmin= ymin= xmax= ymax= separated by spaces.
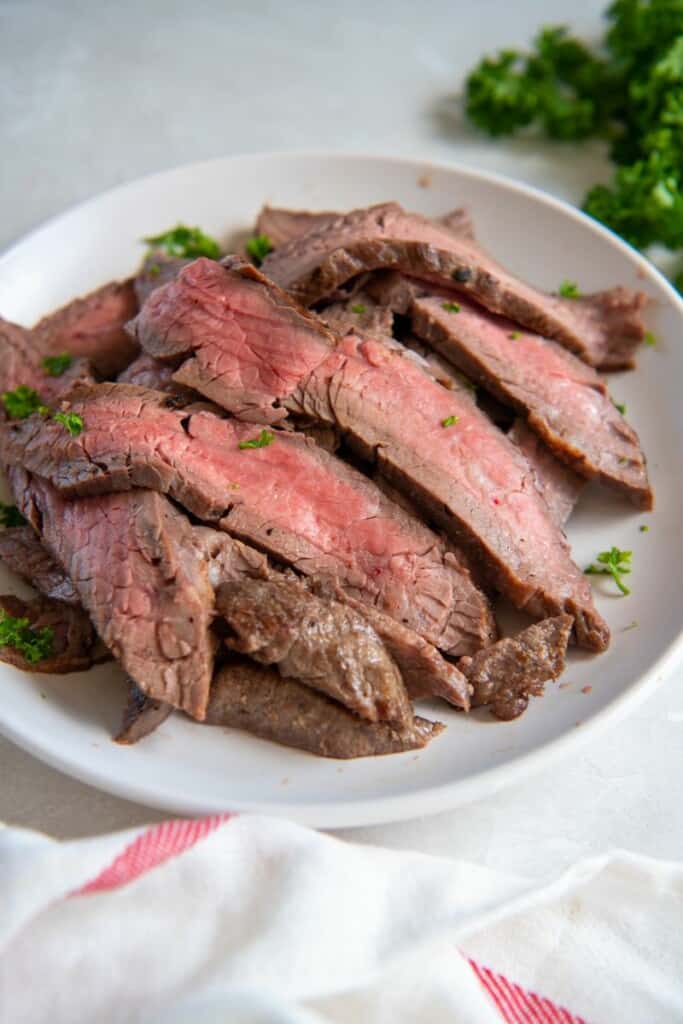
xmin=412 ymin=296 xmax=652 ymax=509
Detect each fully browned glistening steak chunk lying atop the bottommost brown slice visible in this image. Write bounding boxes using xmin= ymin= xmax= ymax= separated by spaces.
xmin=216 ymin=580 xmax=413 ymax=726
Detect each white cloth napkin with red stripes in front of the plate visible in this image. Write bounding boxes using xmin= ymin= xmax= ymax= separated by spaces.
xmin=0 ymin=815 xmax=683 ymax=1024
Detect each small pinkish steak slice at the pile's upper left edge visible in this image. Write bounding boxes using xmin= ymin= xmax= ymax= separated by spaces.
xmin=33 ymin=281 xmax=138 ymax=378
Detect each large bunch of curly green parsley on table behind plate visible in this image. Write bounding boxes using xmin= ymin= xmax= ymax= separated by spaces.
xmin=465 ymin=7 xmax=683 ymax=292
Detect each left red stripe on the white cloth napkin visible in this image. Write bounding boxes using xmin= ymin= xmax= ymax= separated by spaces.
xmin=69 ymin=814 xmax=232 ymax=896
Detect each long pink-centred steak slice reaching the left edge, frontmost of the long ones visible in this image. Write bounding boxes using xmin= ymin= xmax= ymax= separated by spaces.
xmin=0 ymin=385 xmax=495 ymax=655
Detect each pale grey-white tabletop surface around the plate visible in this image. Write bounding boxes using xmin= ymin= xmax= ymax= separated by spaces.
xmin=0 ymin=0 xmax=683 ymax=873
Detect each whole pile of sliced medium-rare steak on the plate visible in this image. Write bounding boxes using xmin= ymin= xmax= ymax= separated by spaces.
xmin=0 ymin=204 xmax=652 ymax=757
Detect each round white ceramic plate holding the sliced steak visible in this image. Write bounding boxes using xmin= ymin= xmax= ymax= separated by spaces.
xmin=0 ymin=154 xmax=683 ymax=827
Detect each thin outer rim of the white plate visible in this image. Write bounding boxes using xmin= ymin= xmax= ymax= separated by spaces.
xmin=0 ymin=148 xmax=683 ymax=828
